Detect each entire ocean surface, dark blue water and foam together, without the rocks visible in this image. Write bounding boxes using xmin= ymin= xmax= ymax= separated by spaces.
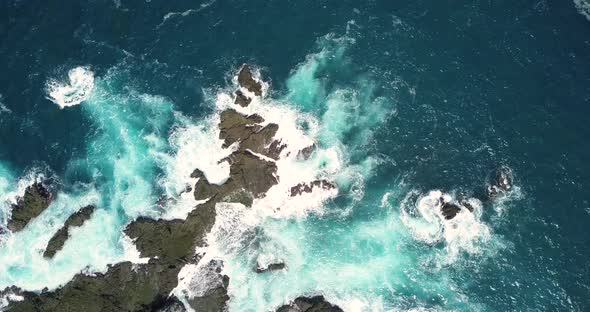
xmin=0 ymin=0 xmax=590 ymax=311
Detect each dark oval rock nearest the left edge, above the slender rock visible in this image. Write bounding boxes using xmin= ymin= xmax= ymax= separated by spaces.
xmin=8 ymin=182 xmax=54 ymax=232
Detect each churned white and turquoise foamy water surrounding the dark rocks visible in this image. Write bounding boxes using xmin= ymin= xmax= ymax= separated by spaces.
xmin=0 ymin=27 xmax=584 ymax=311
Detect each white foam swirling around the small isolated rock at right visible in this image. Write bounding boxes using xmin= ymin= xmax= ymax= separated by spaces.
xmin=400 ymin=190 xmax=492 ymax=263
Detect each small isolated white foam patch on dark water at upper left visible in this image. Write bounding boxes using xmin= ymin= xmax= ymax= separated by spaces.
xmin=46 ymin=67 xmax=94 ymax=109
